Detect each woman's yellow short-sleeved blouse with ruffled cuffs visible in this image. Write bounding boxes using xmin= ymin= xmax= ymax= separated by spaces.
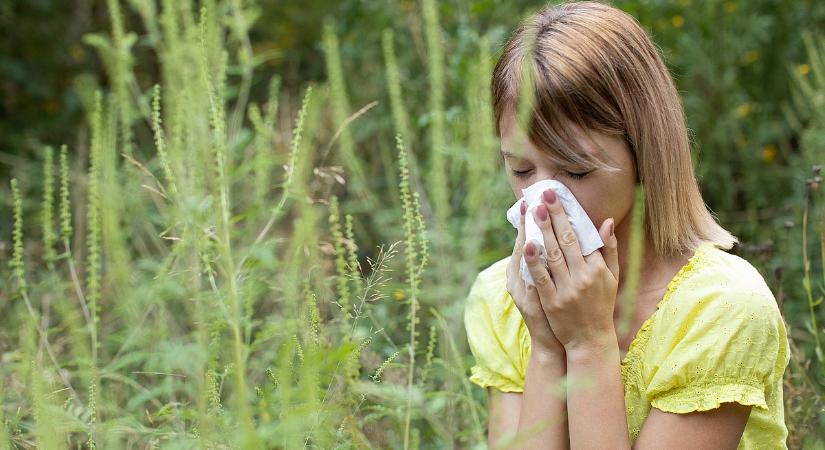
xmin=464 ymin=243 xmax=790 ymax=449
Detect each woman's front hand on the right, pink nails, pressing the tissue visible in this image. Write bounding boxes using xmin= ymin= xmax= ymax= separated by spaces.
xmin=524 ymin=189 xmax=619 ymax=352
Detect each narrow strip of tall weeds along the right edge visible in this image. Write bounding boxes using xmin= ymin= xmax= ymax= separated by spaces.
xmin=780 ymin=32 xmax=825 ymax=448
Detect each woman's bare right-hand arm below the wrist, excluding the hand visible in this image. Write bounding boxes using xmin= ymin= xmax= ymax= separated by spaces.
xmin=567 ymin=342 xmax=751 ymax=450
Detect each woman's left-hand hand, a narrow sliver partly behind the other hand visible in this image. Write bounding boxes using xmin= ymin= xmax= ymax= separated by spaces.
xmin=507 ymin=202 xmax=564 ymax=355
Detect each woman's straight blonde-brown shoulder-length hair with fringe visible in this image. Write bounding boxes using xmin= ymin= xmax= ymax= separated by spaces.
xmin=491 ymin=1 xmax=738 ymax=255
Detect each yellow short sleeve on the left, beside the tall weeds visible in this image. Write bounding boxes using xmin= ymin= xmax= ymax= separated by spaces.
xmin=464 ymin=260 xmax=527 ymax=392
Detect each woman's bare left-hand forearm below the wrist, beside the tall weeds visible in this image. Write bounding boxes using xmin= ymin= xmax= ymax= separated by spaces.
xmin=488 ymin=351 xmax=570 ymax=449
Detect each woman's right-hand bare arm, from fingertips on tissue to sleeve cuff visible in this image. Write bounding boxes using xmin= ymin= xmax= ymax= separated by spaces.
xmin=525 ymin=190 xmax=760 ymax=449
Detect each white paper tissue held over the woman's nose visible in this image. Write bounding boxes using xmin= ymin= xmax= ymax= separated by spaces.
xmin=507 ymin=180 xmax=604 ymax=286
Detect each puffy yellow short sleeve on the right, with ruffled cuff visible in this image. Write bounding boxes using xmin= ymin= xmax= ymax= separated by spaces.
xmin=644 ymin=280 xmax=790 ymax=413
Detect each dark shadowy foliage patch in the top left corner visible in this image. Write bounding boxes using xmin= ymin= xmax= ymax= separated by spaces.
xmin=0 ymin=0 xmax=97 ymax=165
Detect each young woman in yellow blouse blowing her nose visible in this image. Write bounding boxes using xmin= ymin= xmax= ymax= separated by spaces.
xmin=465 ymin=2 xmax=789 ymax=449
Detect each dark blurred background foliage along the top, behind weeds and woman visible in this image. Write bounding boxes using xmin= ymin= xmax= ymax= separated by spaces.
xmin=0 ymin=0 xmax=825 ymax=234
